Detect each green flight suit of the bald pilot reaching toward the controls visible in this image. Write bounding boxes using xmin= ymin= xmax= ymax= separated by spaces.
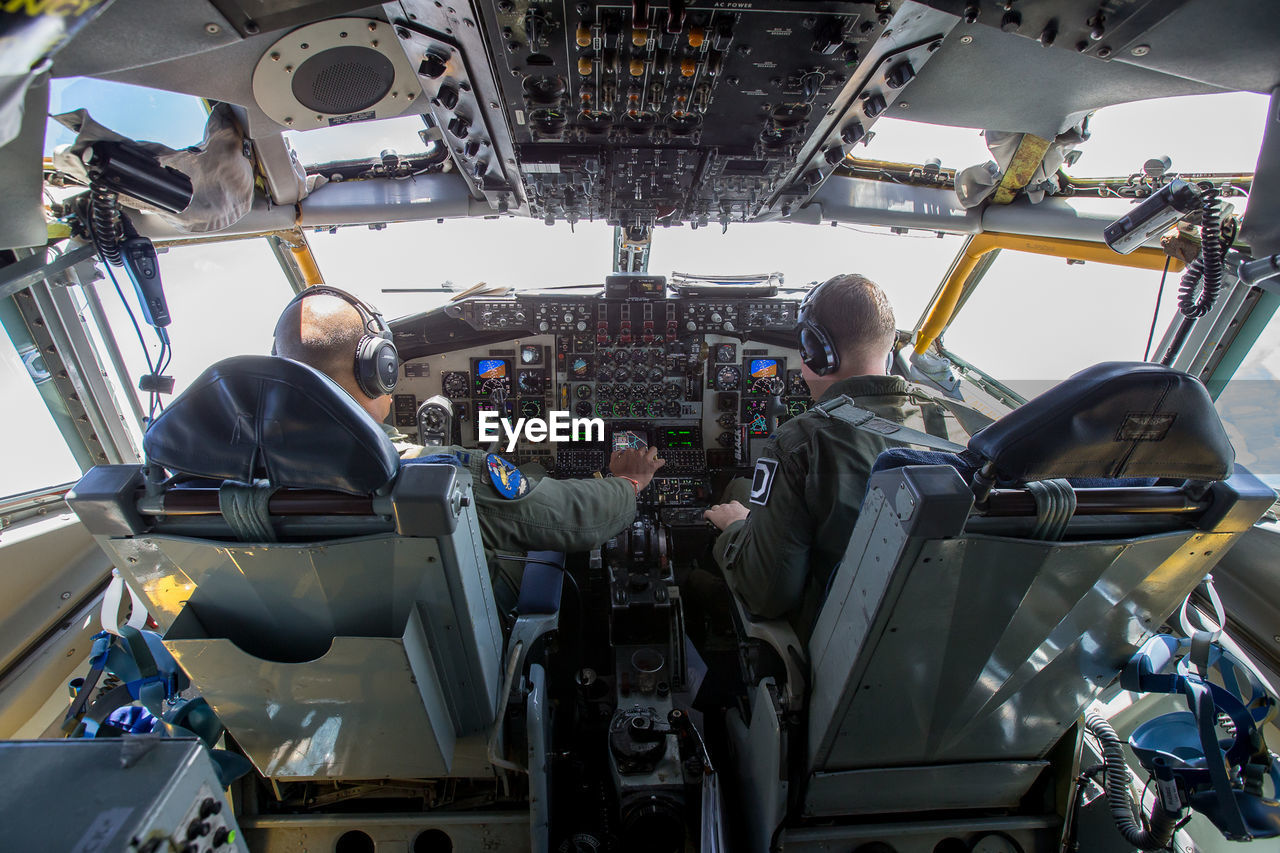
xmin=383 ymin=424 xmax=636 ymax=613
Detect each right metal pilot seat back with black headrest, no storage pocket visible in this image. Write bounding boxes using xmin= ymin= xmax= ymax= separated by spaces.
xmin=804 ymin=365 xmax=1275 ymax=816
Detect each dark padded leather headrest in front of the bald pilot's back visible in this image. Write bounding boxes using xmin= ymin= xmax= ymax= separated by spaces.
xmin=142 ymin=356 xmax=399 ymax=494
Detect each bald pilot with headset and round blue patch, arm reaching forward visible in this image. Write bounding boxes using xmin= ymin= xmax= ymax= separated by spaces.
xmin=271 ymin=286 xmax=664 ymax=612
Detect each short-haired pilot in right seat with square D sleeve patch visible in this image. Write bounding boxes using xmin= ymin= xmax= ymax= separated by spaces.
xmin=705 ymin=274 xmax=919 ymax=639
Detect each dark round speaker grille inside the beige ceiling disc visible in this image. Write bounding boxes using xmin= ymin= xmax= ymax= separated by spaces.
xmin=293 ymin=45 xmax=396 ymax=115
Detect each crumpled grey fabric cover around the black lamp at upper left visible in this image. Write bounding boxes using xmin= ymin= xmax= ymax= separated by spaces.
xmin=54 ymin=104 xmax=253 ymax=234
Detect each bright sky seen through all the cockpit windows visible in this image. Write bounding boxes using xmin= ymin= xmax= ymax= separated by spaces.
xmin=0 ymin=81 xmax=1280 ymax=493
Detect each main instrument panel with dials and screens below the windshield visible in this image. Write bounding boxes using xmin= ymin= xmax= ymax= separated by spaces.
xmin=393 ymin=293 xmax=813 ymax=507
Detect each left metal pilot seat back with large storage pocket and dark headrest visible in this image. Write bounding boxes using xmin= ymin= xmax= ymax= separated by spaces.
xmin=68 ymin=357 xmax=502 ymax=780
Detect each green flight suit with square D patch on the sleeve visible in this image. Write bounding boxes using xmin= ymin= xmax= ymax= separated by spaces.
xmin=714 ymin=375 xmax=919 ymax=640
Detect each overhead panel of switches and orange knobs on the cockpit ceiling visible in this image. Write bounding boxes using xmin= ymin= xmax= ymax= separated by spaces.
xmin=427 ymin=0 xmax=957 ymax=227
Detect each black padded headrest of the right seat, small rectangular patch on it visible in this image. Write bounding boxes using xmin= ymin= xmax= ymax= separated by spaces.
xmin=969 ymin=361 xmax=1235 ymax=483
